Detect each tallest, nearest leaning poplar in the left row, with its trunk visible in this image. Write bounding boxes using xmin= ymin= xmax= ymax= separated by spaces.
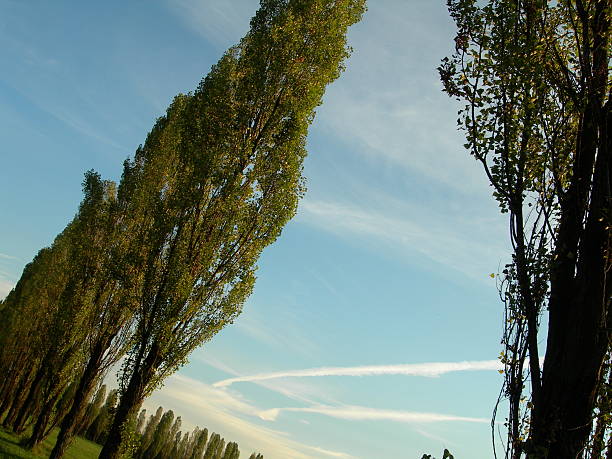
xmin=100 ymin=0 xmax=365 ymax=458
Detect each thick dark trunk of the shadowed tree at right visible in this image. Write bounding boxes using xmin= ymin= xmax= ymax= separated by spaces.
xmin=529 ymin=6 xmax=612 ymax=452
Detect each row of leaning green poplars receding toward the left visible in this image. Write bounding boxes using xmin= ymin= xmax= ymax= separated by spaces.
xmin=0 ymin=0 xmax=365 ymax=458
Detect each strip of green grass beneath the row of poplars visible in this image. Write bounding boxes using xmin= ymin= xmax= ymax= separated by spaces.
xmin=0 ymin=429 xmax=101 ymax=459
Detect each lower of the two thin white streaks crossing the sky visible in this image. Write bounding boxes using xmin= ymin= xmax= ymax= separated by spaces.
xmin=259 ymin=405 xmax=491 ymax=424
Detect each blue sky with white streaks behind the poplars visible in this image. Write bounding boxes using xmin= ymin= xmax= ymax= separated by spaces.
xmin=0 ymin=0 xmax=508 ymax=459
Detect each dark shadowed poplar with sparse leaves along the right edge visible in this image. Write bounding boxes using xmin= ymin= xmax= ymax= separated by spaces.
xmin=439 ymin=0 xmax=612 ymax=459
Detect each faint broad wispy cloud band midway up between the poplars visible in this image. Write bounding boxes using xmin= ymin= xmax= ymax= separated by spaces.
xmin=298 ymin=199 xmax=507 ymax=280
